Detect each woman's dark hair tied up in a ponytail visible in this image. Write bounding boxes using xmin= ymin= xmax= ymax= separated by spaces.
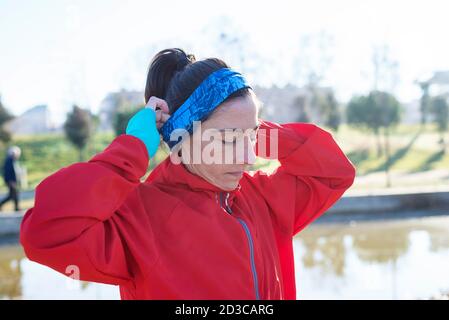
xmin=145 ymin=48 xmax=250 ymax=114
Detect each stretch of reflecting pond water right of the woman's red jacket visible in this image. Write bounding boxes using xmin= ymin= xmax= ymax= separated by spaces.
xmin=294 ymin=217 xmax=449 ymax=299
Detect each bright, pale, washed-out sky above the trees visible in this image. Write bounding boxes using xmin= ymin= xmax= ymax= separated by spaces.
xmin=0 ymin=0 xmax=449 ymax=122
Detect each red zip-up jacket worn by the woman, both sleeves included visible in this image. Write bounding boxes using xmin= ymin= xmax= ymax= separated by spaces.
xmin=20 ymin=121 xmax=355 ymax=299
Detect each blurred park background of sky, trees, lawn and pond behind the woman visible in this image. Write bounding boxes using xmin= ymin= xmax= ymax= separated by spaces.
xmin=0 ymin=0 xmax=449 ymax=299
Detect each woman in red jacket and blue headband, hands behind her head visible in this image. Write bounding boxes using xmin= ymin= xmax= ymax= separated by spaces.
xmin=21 ymin=48 xmax=355 ymax=299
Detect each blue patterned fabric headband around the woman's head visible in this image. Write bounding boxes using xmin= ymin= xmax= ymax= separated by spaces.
xmin=160 ymin=68 xmax=251 ymax=148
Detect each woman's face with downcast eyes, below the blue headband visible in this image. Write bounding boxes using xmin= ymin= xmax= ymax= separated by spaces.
xmin=181 ymin=91 xmax=258 ymax=191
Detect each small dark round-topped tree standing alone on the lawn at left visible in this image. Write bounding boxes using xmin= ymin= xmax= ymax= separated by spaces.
xmin=64 ymin=105 xmax=93 ymax=161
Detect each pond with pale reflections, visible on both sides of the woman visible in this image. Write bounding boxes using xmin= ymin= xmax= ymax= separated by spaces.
xmin=0 ymin=216 xmax=449 ymax=299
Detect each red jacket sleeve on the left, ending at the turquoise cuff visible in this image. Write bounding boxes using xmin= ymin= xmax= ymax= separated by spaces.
xmin=20 ymin=134 xmax=149 ymax=285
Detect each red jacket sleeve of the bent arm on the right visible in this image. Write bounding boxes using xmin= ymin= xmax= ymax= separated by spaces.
xmin=252 ymin=120 xmax=355 ymax=236
